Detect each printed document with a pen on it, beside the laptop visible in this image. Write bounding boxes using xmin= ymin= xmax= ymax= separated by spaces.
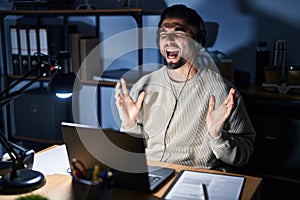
xmin=165 ymin=170 xmax=245 ymax=200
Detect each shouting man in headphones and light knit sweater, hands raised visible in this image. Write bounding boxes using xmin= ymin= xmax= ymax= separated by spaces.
xmin=115 ymin=5 xmax=255 ymax=170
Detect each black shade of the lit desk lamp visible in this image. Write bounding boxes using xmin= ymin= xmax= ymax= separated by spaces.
xmin=48 ymin=70 xmax=82 ymax=94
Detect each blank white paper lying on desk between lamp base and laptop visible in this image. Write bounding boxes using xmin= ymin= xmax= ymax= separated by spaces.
xmin=32 ymin=144 xmax=70 ymax=176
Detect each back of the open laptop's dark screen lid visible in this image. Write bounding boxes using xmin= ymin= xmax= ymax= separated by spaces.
xmin=61 ymin=122 xmax=147 ymax=173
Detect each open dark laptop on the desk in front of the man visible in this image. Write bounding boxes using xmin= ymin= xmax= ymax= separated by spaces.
xmin=61 ymin=122 xmax=175 ymax=192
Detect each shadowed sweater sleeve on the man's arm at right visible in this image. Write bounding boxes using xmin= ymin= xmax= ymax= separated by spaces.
xmin=210 ymin=88 xmax=256 ymax=166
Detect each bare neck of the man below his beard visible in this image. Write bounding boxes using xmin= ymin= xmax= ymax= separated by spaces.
xmin=167 ymin=62 xmax=198 ymax=82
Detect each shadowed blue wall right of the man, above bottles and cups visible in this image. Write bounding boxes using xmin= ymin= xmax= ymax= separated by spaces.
xmin=166 ymin=0 xmax=300 ymax=83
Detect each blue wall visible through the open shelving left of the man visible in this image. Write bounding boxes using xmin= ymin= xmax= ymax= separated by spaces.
xmin=74 ymin=16 xmax=161 ymax=129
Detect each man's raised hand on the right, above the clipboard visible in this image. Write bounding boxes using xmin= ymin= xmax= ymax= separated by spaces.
xmin=206 ymin=88 xmax=235 ymax=138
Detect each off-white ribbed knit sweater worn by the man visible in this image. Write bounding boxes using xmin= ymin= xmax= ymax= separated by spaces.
xmin=122 ymin=67 xmax=255 ymax=170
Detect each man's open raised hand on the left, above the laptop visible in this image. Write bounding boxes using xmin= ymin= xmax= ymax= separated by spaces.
xmin=115 ymin=79 xmax=146 ymax=129
